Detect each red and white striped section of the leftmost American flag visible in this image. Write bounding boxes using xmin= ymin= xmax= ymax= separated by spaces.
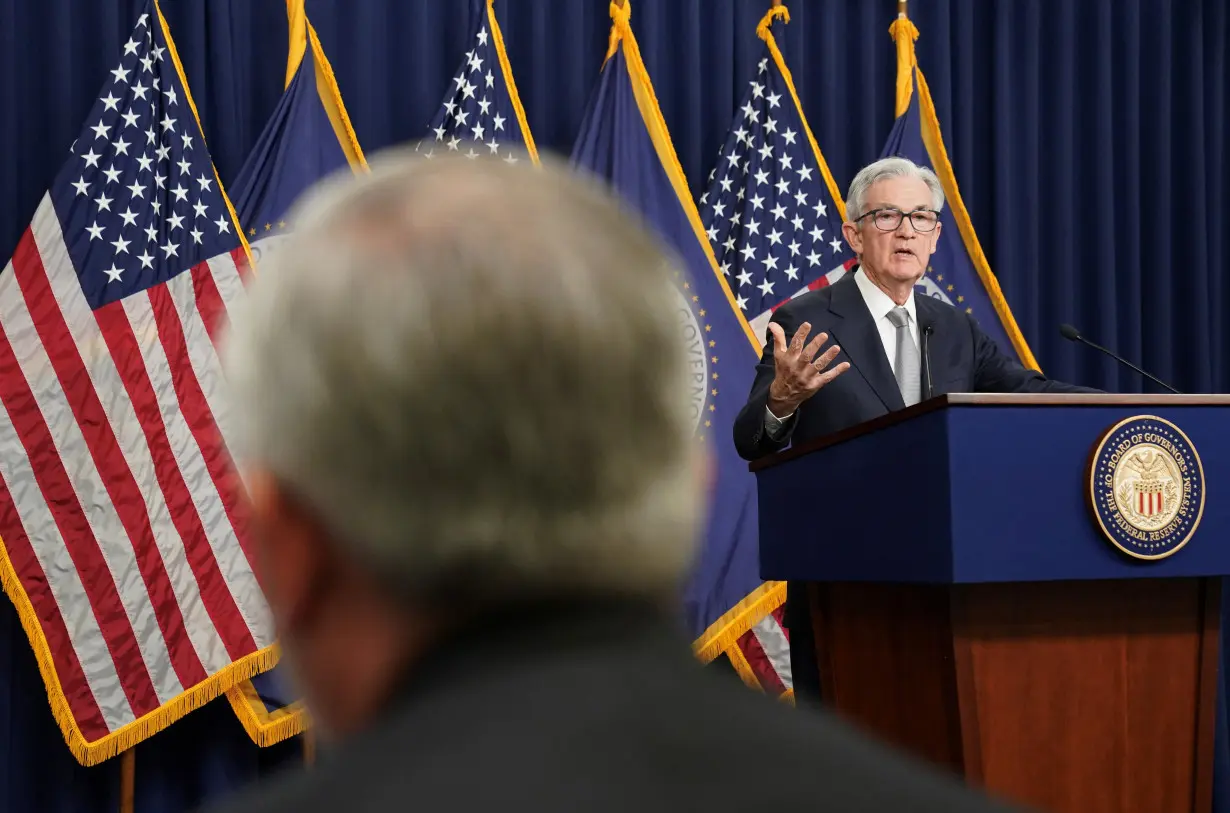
xmin=0 ymin=197 xmax=274 ymax=743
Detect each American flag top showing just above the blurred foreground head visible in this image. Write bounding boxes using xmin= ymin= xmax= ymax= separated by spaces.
xmin=418 ymin=0 xmax=538 ymax=164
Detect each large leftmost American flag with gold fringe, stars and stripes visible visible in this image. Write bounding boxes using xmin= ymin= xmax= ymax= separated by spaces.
xmin=0 ymin=0 xmax=274 ymax=765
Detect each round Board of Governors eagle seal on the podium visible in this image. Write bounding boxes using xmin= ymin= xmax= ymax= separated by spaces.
xmin=1089 ymin=414 xmax=1204 ymax=560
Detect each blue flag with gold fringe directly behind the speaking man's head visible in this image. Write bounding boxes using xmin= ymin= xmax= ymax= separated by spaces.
xmin=882 ymin=16 xmax=1039 ymax=369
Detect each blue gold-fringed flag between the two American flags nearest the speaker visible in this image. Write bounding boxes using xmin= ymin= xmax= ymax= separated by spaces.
xmin=572 ymin=4 xmax=785 ymax=679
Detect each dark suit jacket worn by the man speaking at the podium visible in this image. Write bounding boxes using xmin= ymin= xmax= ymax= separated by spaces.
xmin=734 ymin=274 xmax=1096 ymax=460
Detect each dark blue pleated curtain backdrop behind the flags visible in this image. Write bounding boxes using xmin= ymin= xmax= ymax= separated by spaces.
xmin=0 ymin=0 xmax=1230 ymax=813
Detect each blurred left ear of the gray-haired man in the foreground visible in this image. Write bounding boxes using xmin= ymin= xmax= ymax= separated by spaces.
xmin=244 ymin=469 xmax=328 ymax=633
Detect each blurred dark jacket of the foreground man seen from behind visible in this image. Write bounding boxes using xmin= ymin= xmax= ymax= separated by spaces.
xmin=206 ymin=595 xmax=1023 ymax=813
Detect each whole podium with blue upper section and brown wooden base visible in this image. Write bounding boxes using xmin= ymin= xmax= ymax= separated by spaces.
xmin=752 ymin=395 xmax=1230 ymax=813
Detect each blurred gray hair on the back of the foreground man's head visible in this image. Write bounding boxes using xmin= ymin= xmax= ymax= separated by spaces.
xmin=224 ymin=150 xmax=704 ymax=600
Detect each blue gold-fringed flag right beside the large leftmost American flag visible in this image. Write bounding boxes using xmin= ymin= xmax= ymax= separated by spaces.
xmin=226 ymin=0 xmax=367 ymax=747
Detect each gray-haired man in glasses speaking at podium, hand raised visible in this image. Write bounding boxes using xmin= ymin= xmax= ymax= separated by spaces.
xmin=734 ymin=157 xmax=1097 ymax=696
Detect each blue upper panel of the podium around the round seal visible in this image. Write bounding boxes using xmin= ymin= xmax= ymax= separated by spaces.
xmin=756 ymin=403 xmax=1230 ymax=584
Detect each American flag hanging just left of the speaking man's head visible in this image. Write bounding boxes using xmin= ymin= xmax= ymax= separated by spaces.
xmin=700 ymin=6 xmax=854 ymax=694
